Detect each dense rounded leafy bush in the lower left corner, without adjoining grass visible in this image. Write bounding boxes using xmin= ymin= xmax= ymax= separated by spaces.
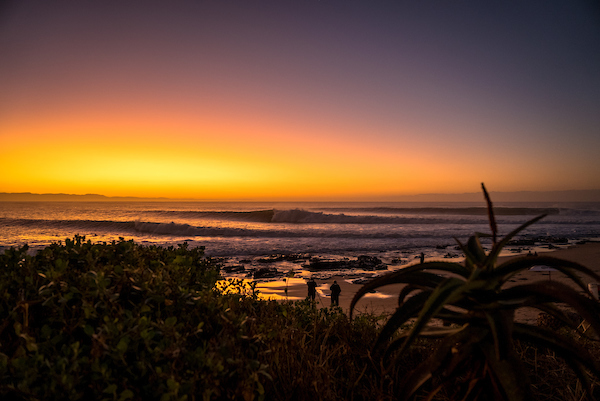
xmin=0 ymin=237 xmax=269 ymax=400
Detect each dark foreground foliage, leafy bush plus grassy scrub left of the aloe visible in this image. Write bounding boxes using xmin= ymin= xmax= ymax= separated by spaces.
xmin=0 ymin=236 xmax=384 ymax=400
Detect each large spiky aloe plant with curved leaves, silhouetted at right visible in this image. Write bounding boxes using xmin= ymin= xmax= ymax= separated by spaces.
xmin=350 ymin=184 xmax=600 ymax=400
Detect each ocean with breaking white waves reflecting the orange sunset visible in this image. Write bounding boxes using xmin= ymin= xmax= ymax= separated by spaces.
xmin=0 ymin=201 xmax=600 ymax=282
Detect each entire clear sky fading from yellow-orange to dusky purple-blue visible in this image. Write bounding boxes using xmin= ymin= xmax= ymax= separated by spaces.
xmin=0 ymin=0 xmax=600 ymax=199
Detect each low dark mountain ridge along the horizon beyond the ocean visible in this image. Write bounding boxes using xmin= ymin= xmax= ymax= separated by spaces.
xmin=0 ymin=189 xmax=600 ymax=202
